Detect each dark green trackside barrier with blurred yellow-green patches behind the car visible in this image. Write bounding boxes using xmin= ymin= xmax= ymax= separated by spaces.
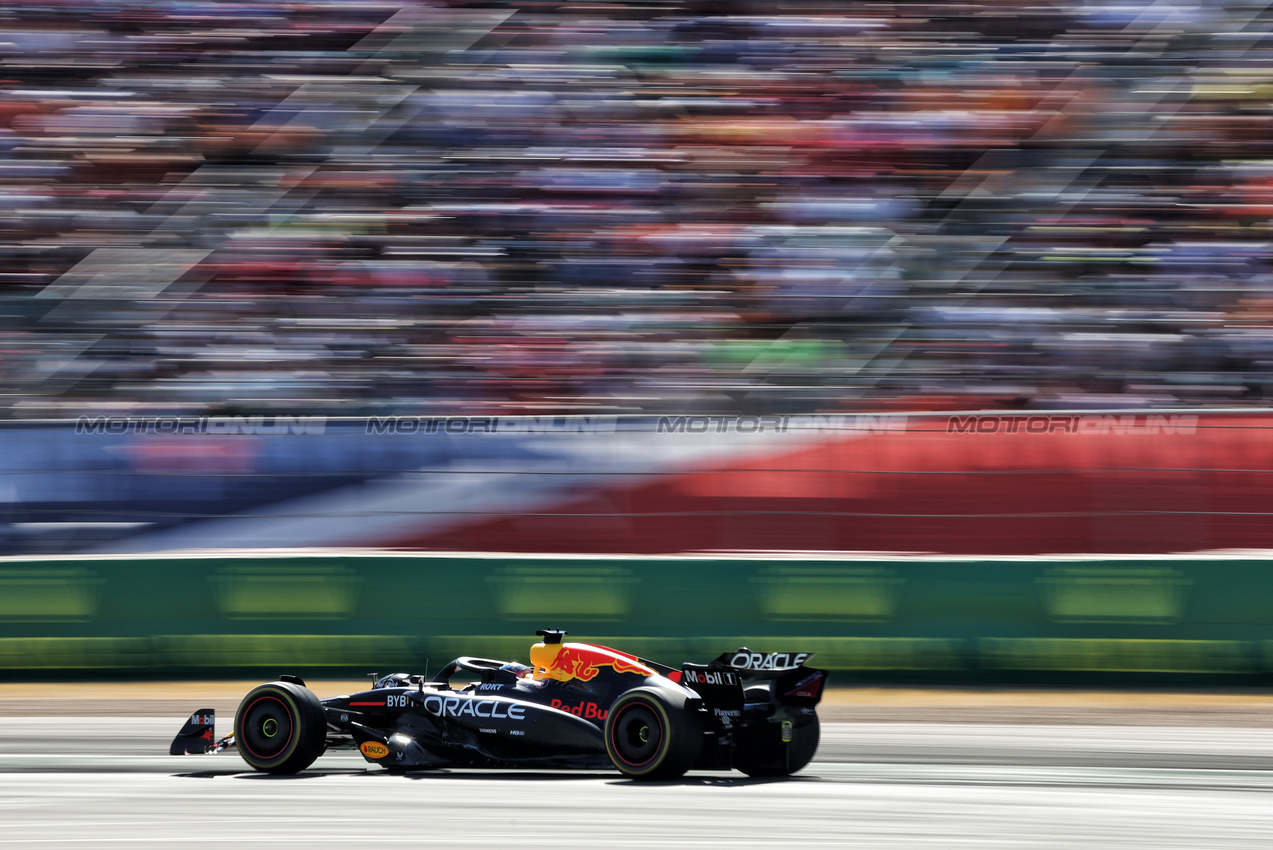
xmin=0 ymin=552 xmax=1273 ymax=682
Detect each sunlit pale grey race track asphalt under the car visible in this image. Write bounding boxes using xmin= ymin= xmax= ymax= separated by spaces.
xmin=0 ymin=700 xmax=1273 ymax=850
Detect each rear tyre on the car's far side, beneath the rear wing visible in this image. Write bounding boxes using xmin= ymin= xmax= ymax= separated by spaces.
xmin=733 ymin=686 xmax=821 ymax=776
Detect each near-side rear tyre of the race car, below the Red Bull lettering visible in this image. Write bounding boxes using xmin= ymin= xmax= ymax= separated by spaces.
xmin=606 ymin=687 xmax=703 ymax=779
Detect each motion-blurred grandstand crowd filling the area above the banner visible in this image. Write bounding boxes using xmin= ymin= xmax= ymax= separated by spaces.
xmin=0 ymin=0 xmax=1273 ymax=419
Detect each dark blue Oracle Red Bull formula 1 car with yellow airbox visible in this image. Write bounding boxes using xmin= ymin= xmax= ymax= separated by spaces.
xmin=171 ymin=630 xmax=826 ymax=779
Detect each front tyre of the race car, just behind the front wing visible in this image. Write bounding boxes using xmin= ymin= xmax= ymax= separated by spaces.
xmin=234 ymin=682 xmax=327 ymax=774
